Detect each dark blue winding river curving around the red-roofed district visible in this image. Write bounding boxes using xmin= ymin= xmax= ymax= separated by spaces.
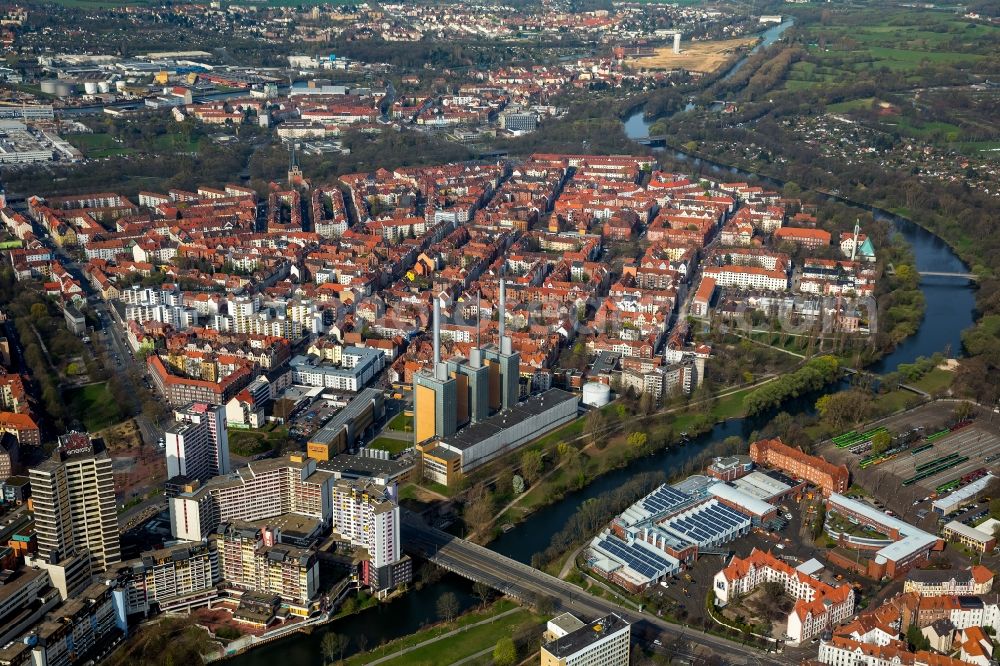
xmin=229 ymin=21 xmax=975 ymax=666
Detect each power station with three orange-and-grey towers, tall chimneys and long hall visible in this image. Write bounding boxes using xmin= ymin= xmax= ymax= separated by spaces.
xmin=413 ymin=280 xmax=580 ymax=485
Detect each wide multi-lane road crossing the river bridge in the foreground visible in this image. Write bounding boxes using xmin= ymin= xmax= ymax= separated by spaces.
xmin=402 ymin=514 xmax=792 ymax=664
